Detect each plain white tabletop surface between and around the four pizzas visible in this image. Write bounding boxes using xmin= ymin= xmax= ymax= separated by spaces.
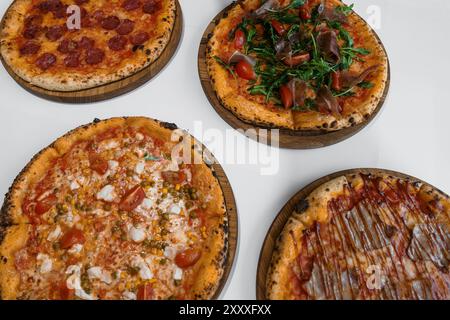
xmin=0 ymin=0 xmax=450 ymax=299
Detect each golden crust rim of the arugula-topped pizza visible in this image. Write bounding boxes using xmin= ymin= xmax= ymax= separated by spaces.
xmin=207 ymin=0 xmax=389 ymax=131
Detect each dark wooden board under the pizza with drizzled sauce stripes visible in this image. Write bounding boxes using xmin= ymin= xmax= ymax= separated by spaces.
xmin=256 ymin=168 xmax=448 ymax=300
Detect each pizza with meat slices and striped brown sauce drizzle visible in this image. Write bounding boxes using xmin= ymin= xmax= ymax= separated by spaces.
xmin=266 ymin=171 xmax=450 ymax=300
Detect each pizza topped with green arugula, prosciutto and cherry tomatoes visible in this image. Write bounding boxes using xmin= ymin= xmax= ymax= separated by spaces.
xmin=207 ymin=0 xmax=388 ymax=131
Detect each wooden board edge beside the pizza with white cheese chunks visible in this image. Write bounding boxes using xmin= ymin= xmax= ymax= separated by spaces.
xmin=211 ymin=161 xmax=238 ymax=299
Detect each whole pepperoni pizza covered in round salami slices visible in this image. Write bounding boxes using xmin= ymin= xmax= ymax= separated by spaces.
xmin=0 ymin=0 xmax=176 ymax=91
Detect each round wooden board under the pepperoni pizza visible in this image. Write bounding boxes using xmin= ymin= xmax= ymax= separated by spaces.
xmin=0 ymin=1 xmax=183 ymax=103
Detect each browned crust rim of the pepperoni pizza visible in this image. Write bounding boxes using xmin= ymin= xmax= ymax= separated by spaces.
xmin=0 ymin=0 xmax=177 ymax=91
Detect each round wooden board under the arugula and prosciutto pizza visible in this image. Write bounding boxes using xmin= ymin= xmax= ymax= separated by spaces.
xmin=198 ymin=3 xmax=391 ymax=149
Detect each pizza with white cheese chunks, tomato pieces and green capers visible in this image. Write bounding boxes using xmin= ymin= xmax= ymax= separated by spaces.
xmin=0 ymin=118 xmax=228 ymax=300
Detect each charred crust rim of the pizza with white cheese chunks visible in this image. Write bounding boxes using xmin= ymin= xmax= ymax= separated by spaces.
xmin=0 ymin=117 xmax=228 ymax=299
